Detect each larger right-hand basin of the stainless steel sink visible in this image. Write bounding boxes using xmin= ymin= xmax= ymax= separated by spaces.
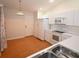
xmin=51 ymin=45 xmax=79 ymax=58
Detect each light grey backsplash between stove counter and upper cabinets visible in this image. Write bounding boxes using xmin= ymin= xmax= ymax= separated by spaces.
xmin=51 ymin=25 xmax=79 ymax=35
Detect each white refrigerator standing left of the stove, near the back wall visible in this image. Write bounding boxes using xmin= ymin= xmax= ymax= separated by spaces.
xmin=38 ymin=18 xmax=49 ymax=40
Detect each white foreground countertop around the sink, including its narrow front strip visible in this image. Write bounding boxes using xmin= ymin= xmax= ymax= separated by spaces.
xmin=27 ymin=33 xmax=79 ymax=58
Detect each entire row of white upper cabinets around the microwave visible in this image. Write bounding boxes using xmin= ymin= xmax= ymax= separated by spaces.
xmin=49 ymin=10 xmax=79 ymax=26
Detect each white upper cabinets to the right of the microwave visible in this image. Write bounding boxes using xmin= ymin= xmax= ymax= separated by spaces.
xmin=65 ymin=10 xmax=79 ymax=26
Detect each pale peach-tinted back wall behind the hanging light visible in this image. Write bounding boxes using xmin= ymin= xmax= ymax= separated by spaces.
xmin=4 ymin=8 xmax=34 ymax=39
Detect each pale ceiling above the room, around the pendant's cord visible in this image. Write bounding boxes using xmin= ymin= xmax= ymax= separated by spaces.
xmin=0 ymin=0 xmax=63 ymax=12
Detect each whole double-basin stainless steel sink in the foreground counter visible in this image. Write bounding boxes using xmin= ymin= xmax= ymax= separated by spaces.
xmin=33 ymin=45 xmax=79 ymax=58
